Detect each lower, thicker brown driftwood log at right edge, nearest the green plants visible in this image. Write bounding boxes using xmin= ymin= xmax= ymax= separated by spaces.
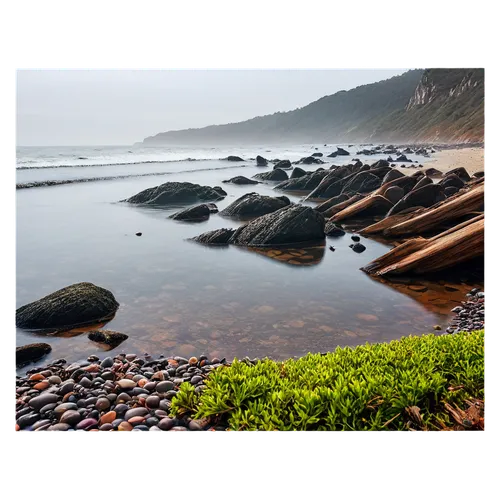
xmin=362 ymin=216 xmax=486 ymax=276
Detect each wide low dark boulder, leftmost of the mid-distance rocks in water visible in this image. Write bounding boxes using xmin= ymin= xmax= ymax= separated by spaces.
xmin=122 ymin=182 xmax=227 ymax=207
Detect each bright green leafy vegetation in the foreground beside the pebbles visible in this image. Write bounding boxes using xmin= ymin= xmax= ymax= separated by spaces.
xmin=172 ymin=330 xmax=488 ymax=433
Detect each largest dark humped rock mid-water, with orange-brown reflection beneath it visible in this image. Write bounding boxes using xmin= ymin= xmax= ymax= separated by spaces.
xmin=193 ymin=205 xmax=325 ymax=247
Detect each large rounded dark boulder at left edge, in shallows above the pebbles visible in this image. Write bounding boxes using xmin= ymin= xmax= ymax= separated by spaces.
xmin=14 ymin=282 xmax=120 ymax=331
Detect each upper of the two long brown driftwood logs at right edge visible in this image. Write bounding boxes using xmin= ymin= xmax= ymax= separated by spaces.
xmin=384 ymin=182 xmax=486 ymax=236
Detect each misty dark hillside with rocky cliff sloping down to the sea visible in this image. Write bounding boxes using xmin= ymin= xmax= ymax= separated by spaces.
xmin=143 ymin=66 xmax=486 ymax=145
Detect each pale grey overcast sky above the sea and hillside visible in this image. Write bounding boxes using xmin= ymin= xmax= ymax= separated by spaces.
xmin=9 ymin=64 xmax=408 ymax=146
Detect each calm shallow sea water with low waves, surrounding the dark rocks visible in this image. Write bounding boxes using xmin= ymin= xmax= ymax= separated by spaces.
xmin=15 ymin=145 xmax=480 ymax=372
